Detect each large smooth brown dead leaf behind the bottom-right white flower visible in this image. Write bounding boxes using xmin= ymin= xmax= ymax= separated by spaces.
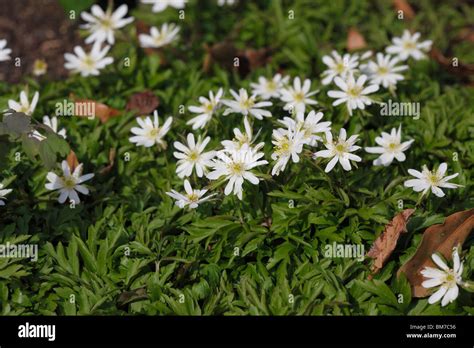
xmin=398 ymin=209 xmax=474 ymax=297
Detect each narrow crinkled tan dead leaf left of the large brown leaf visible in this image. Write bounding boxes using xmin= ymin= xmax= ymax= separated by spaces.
xmin=367 ymin=209 xmax=415 ymax=279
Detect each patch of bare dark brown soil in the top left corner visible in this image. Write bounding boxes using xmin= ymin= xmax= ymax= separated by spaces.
xmin=0 ymin=0 xmax=82 ymax=83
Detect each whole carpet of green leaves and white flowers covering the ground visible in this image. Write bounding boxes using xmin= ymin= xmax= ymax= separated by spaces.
xmin=0 ymin=0 xmax=474 ymax=315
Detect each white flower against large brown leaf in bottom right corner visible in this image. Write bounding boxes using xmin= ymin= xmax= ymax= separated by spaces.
xmin=420 ymin=248 xmax=463 ymax=307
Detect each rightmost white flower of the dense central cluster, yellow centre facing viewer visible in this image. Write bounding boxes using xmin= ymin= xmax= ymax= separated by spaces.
xmin=314 ymin=128 xmax=362 ymax=173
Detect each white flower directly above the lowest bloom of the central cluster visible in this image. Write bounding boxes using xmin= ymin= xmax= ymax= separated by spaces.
xmin=173 ymin=133 xmax=216 ymax=178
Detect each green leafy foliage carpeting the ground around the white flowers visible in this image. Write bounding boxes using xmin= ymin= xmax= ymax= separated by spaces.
xmin=0 ymin=0 xmax=474 ymax=315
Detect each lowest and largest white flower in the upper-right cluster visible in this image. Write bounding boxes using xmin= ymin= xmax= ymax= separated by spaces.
xmin=328 ymin=74 xmax=379 ymax=116
